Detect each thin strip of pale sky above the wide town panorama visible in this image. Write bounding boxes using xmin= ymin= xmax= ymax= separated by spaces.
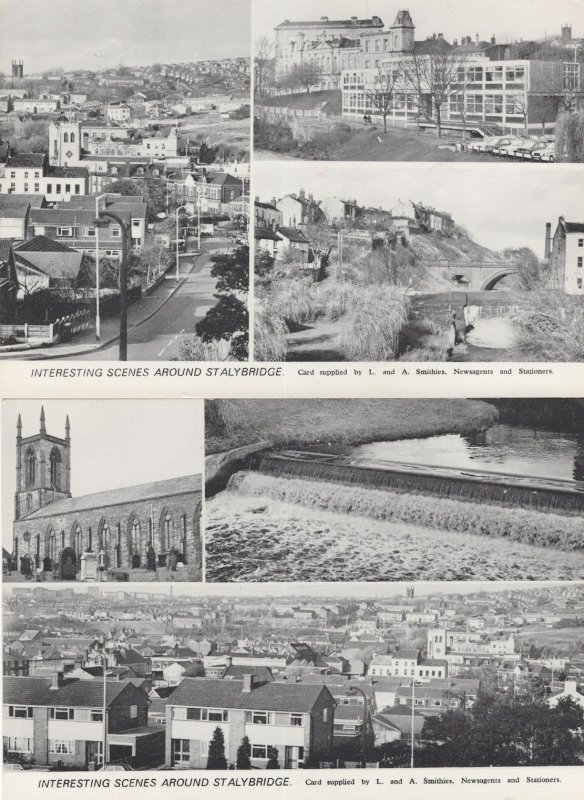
xmin=3 ymin=581 xmax=584 ymax=602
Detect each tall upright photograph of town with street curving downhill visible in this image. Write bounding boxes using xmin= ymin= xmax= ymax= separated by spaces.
xmin=0 ymin=0 xmax=251 ymax=361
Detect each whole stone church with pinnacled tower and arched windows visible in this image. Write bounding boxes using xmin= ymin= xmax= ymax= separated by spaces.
xmin=11 ymin=408 xmax=202 ymax=580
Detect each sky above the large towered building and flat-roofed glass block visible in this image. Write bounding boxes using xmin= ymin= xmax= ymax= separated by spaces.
xmin=252 ymin=0 xmax=584 ymax=42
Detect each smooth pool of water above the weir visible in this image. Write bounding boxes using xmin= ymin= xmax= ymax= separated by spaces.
xmin=346 ymin=425 xmax=584 ymax=481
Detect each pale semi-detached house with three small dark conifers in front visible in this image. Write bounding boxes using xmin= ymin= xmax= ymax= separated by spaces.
xmin=166 ymin=674 xmax=335 ymax=769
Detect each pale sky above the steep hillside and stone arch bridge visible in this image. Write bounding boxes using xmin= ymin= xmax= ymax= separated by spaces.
xmin=253 ymin=161 xmax=584 ymax=258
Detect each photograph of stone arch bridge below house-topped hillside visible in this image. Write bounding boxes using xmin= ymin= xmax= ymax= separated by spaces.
xmin=254 ymin=162 xmax=584 ymax=362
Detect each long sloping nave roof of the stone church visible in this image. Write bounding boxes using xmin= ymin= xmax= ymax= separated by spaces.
xmin=18 ymin=475 xmax=201 ymax=521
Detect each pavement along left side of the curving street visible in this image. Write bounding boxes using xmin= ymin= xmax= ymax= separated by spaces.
xmin=0 ymin=253 xmax=200 ymax=361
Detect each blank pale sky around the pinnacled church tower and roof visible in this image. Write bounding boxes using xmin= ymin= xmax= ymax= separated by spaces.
xmin=1 ymin=400 xmax=204 ymax=551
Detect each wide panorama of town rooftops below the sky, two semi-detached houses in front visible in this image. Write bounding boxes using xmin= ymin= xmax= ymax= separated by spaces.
xmin=3 ymin=583 xmax=584 ymax=770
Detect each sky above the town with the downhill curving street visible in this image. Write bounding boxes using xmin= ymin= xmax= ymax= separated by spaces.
xmin=0 ymin=0 xmax=250 ymax=77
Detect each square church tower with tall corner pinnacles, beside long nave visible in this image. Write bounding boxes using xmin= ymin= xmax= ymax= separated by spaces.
xmin=14 ymin=407 xmax=71 ymax=520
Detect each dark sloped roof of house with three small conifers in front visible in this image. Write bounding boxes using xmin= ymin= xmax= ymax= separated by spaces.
xmin=169 ymin=678 xmax=333 ymax=712
